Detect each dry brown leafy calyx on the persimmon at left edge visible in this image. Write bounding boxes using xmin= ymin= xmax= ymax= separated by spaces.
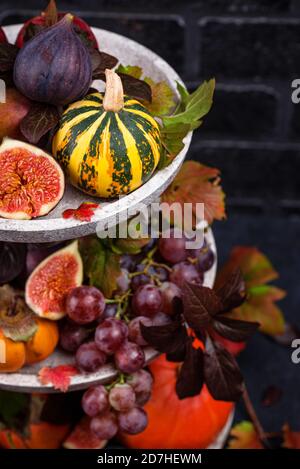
xmin=0 ymin=285 xmax=37 ymax=342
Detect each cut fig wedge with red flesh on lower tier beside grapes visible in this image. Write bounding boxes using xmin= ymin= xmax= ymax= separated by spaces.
xmin=25 ymin=241 xmax=83 ymax=321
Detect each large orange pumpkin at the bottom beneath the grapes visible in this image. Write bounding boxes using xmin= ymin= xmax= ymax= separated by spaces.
xmin=120 ymin=356 xmax=233 ymax=449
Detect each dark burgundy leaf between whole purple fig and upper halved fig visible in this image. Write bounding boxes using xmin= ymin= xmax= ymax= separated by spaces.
xmin=20 ymin=103 xmax=60 ymax=143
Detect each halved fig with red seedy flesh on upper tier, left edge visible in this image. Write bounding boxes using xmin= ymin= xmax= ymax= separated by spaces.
xmin=0 ymin=138 xmax=65 ymax=220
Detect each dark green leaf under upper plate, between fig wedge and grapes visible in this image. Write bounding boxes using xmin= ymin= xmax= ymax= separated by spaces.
xmin=79 ymin=237 xmax=121 ymax=298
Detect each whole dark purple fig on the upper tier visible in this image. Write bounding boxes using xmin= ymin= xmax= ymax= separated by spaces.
xmin=14 ymin=14 xmax=92 ymax=106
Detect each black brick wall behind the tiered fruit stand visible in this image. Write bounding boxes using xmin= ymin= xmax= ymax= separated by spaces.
xmin=0 ymin=0 xmax=300 ymax=214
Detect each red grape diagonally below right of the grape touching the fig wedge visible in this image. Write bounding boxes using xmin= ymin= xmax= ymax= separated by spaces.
xmin=95 ymin=318 xmax=128 ymax=355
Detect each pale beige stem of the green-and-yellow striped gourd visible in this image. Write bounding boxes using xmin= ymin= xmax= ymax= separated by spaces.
xmin=103 ymin=68 xmax=124 ymax=112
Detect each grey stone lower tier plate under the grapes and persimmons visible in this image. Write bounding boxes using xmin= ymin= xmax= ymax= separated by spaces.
xmin=0 ymin=229 xmax=217 ymax=393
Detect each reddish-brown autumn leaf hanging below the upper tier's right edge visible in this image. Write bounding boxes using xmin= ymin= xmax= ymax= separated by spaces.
xmin=162 ymin=161 xmax=225 ymax=224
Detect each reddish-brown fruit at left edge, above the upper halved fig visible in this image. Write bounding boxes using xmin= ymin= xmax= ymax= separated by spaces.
xmin=0 ymin=88 xmax=32 ymax=140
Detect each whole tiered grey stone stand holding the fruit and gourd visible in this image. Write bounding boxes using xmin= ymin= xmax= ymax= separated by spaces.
xmin=0 ymin=25 xmax=232 ymax=447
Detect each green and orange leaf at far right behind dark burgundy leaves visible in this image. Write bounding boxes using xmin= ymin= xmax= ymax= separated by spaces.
xmin=216 ymin=246 xmax=285 ymax=337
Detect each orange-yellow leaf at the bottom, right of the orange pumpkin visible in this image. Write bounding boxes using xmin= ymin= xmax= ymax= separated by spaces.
xmin=228 ymin=420 xmax=264 ymax=449
